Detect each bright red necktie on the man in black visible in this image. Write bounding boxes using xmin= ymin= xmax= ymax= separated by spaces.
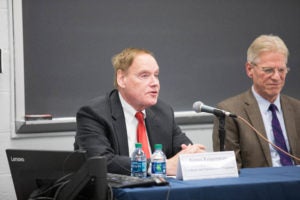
xmin=135 ymin=112 xmax=150 ymax=158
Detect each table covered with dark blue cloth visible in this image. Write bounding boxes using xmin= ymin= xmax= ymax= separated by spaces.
xmin=113 ymin=166 xmax=300 ymax=200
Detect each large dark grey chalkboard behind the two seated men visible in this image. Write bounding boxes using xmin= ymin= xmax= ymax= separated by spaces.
xmin=22 ymin=0 xmax=300 ymax=117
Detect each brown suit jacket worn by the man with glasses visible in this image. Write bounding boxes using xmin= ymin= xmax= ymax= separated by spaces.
xmin=213 ymin=89 xmax=300 ymax=168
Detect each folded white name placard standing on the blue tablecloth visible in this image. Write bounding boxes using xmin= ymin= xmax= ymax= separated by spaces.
xmin=176 ymin=151 xmax=238 ymax=180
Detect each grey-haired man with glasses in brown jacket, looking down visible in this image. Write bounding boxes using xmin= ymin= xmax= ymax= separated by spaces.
xmin=213 ymin=35 xmax=300 ymax=168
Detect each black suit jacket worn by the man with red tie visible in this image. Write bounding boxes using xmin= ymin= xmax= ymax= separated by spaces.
xmin=74 ymin=90 xmax=192 ymax=174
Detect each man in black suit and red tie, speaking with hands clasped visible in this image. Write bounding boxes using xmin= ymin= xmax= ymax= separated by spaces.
xmin=74 ymin=48 xmax=204 ymax=175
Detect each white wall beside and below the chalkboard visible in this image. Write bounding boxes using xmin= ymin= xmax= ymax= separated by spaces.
xmin=0 ymin=0 xmax=212 ymax=200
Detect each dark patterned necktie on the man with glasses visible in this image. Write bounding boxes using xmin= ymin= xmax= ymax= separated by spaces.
xmin=269 ymin=104 xmax=293 ymax=166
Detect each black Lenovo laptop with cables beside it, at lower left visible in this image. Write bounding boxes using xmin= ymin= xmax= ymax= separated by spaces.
xmin=6 ymin=149 xmax=107 ymax=200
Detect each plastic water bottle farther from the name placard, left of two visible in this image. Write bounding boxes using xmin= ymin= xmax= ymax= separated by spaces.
xmin=131 ymin=143 xmax=147 ymax=178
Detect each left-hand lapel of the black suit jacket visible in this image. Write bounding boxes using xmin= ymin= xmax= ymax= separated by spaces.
xmin=109 ymin=90 xmax=129 ymax=156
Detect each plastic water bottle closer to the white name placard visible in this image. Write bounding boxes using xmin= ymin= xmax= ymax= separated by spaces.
xmin=151 ymin=144 xmax=166 ymax=177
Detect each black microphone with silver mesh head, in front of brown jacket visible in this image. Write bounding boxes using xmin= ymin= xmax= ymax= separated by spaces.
xmin=193 ymin=101 xmax=237 ymax=118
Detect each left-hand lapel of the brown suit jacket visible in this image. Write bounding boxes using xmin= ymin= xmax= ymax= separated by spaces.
xmin=245 ymin=90 xmax=272 ymax=166
